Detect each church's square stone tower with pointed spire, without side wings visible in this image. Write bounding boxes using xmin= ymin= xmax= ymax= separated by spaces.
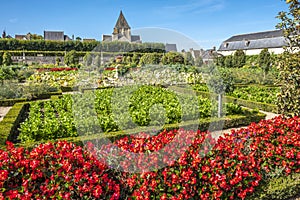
xmin=112 ymin=11 xmax=131 ymax=42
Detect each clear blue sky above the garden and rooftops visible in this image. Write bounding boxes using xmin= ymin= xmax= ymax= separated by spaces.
xmin=0 ymin=0 xmax=287 ymax=50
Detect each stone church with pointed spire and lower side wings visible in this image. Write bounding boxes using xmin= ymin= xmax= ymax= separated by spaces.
xmin=102 ymin=11 xmax=142 ymax=43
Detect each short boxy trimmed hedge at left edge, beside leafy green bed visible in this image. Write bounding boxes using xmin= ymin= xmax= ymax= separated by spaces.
xmin=0 ymin=103 xmax=29 ymax=148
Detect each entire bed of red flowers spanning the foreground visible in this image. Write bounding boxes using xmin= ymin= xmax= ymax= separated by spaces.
xmin=0 ymin=117 xmax=300 ymax=200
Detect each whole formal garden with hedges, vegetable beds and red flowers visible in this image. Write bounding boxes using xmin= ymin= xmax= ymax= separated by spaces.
xmin=0 ymin=1 xmax=300 ymax=200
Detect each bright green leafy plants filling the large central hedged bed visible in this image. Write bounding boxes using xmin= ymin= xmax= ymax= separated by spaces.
xmin=19 ymin=86 xmax=243 ymax=142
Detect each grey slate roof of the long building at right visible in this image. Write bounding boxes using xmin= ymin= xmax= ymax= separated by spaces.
xmin=218 ymin=30 xmax=287 ymax=51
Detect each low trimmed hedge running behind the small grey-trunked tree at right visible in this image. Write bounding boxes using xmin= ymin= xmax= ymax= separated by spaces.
xmin=196 ymin=91 xmax=278 ymax=113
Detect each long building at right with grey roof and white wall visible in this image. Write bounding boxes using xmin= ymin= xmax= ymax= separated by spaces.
xmin=218 ymin=30 xmax=288 ymax=56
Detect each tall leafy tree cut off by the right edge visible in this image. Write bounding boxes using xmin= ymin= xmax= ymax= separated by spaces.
xmin=277 ymin=0 xmax=300 ymax=116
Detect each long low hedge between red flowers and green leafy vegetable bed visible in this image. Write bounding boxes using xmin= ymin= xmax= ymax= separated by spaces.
xmin=16 ymin=109 xmax=266 ymax=149
